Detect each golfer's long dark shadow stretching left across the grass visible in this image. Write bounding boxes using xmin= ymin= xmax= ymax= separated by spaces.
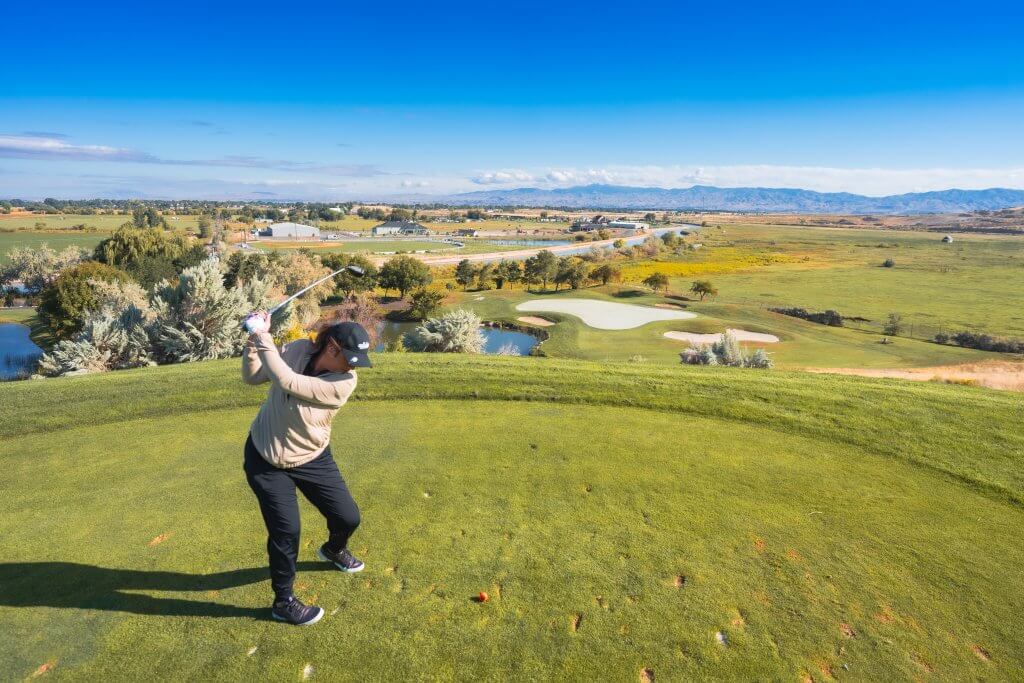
xmin=0 ymin=562 xmax=332 ymax=620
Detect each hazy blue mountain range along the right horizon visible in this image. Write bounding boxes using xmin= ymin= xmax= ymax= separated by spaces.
xmin=432 ymin=184 xmax=1024 ymax=214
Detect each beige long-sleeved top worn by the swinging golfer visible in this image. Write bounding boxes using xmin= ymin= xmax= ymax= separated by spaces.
xmin=242 ymin=333 xmax=356 ymax=469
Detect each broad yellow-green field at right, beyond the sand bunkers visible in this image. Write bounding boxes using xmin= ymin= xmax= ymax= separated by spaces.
xmin=655 ymin=224 xmax=1024 ymax=337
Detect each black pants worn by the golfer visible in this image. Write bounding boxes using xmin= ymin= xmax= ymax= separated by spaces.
xmin=245 ymin=437 xmax=359 ymax=599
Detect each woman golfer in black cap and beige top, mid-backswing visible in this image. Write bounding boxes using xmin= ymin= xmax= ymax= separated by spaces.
xmin=242 ymin=313 xmax=372 ymax=626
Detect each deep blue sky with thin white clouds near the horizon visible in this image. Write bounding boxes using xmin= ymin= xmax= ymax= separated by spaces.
xmin=0 ymin=2 xmax=1024 ymax=200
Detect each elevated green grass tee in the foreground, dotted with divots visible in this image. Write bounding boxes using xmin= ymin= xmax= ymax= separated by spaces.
xmin=0 ymin=354 xmax=1024 ymax=681
